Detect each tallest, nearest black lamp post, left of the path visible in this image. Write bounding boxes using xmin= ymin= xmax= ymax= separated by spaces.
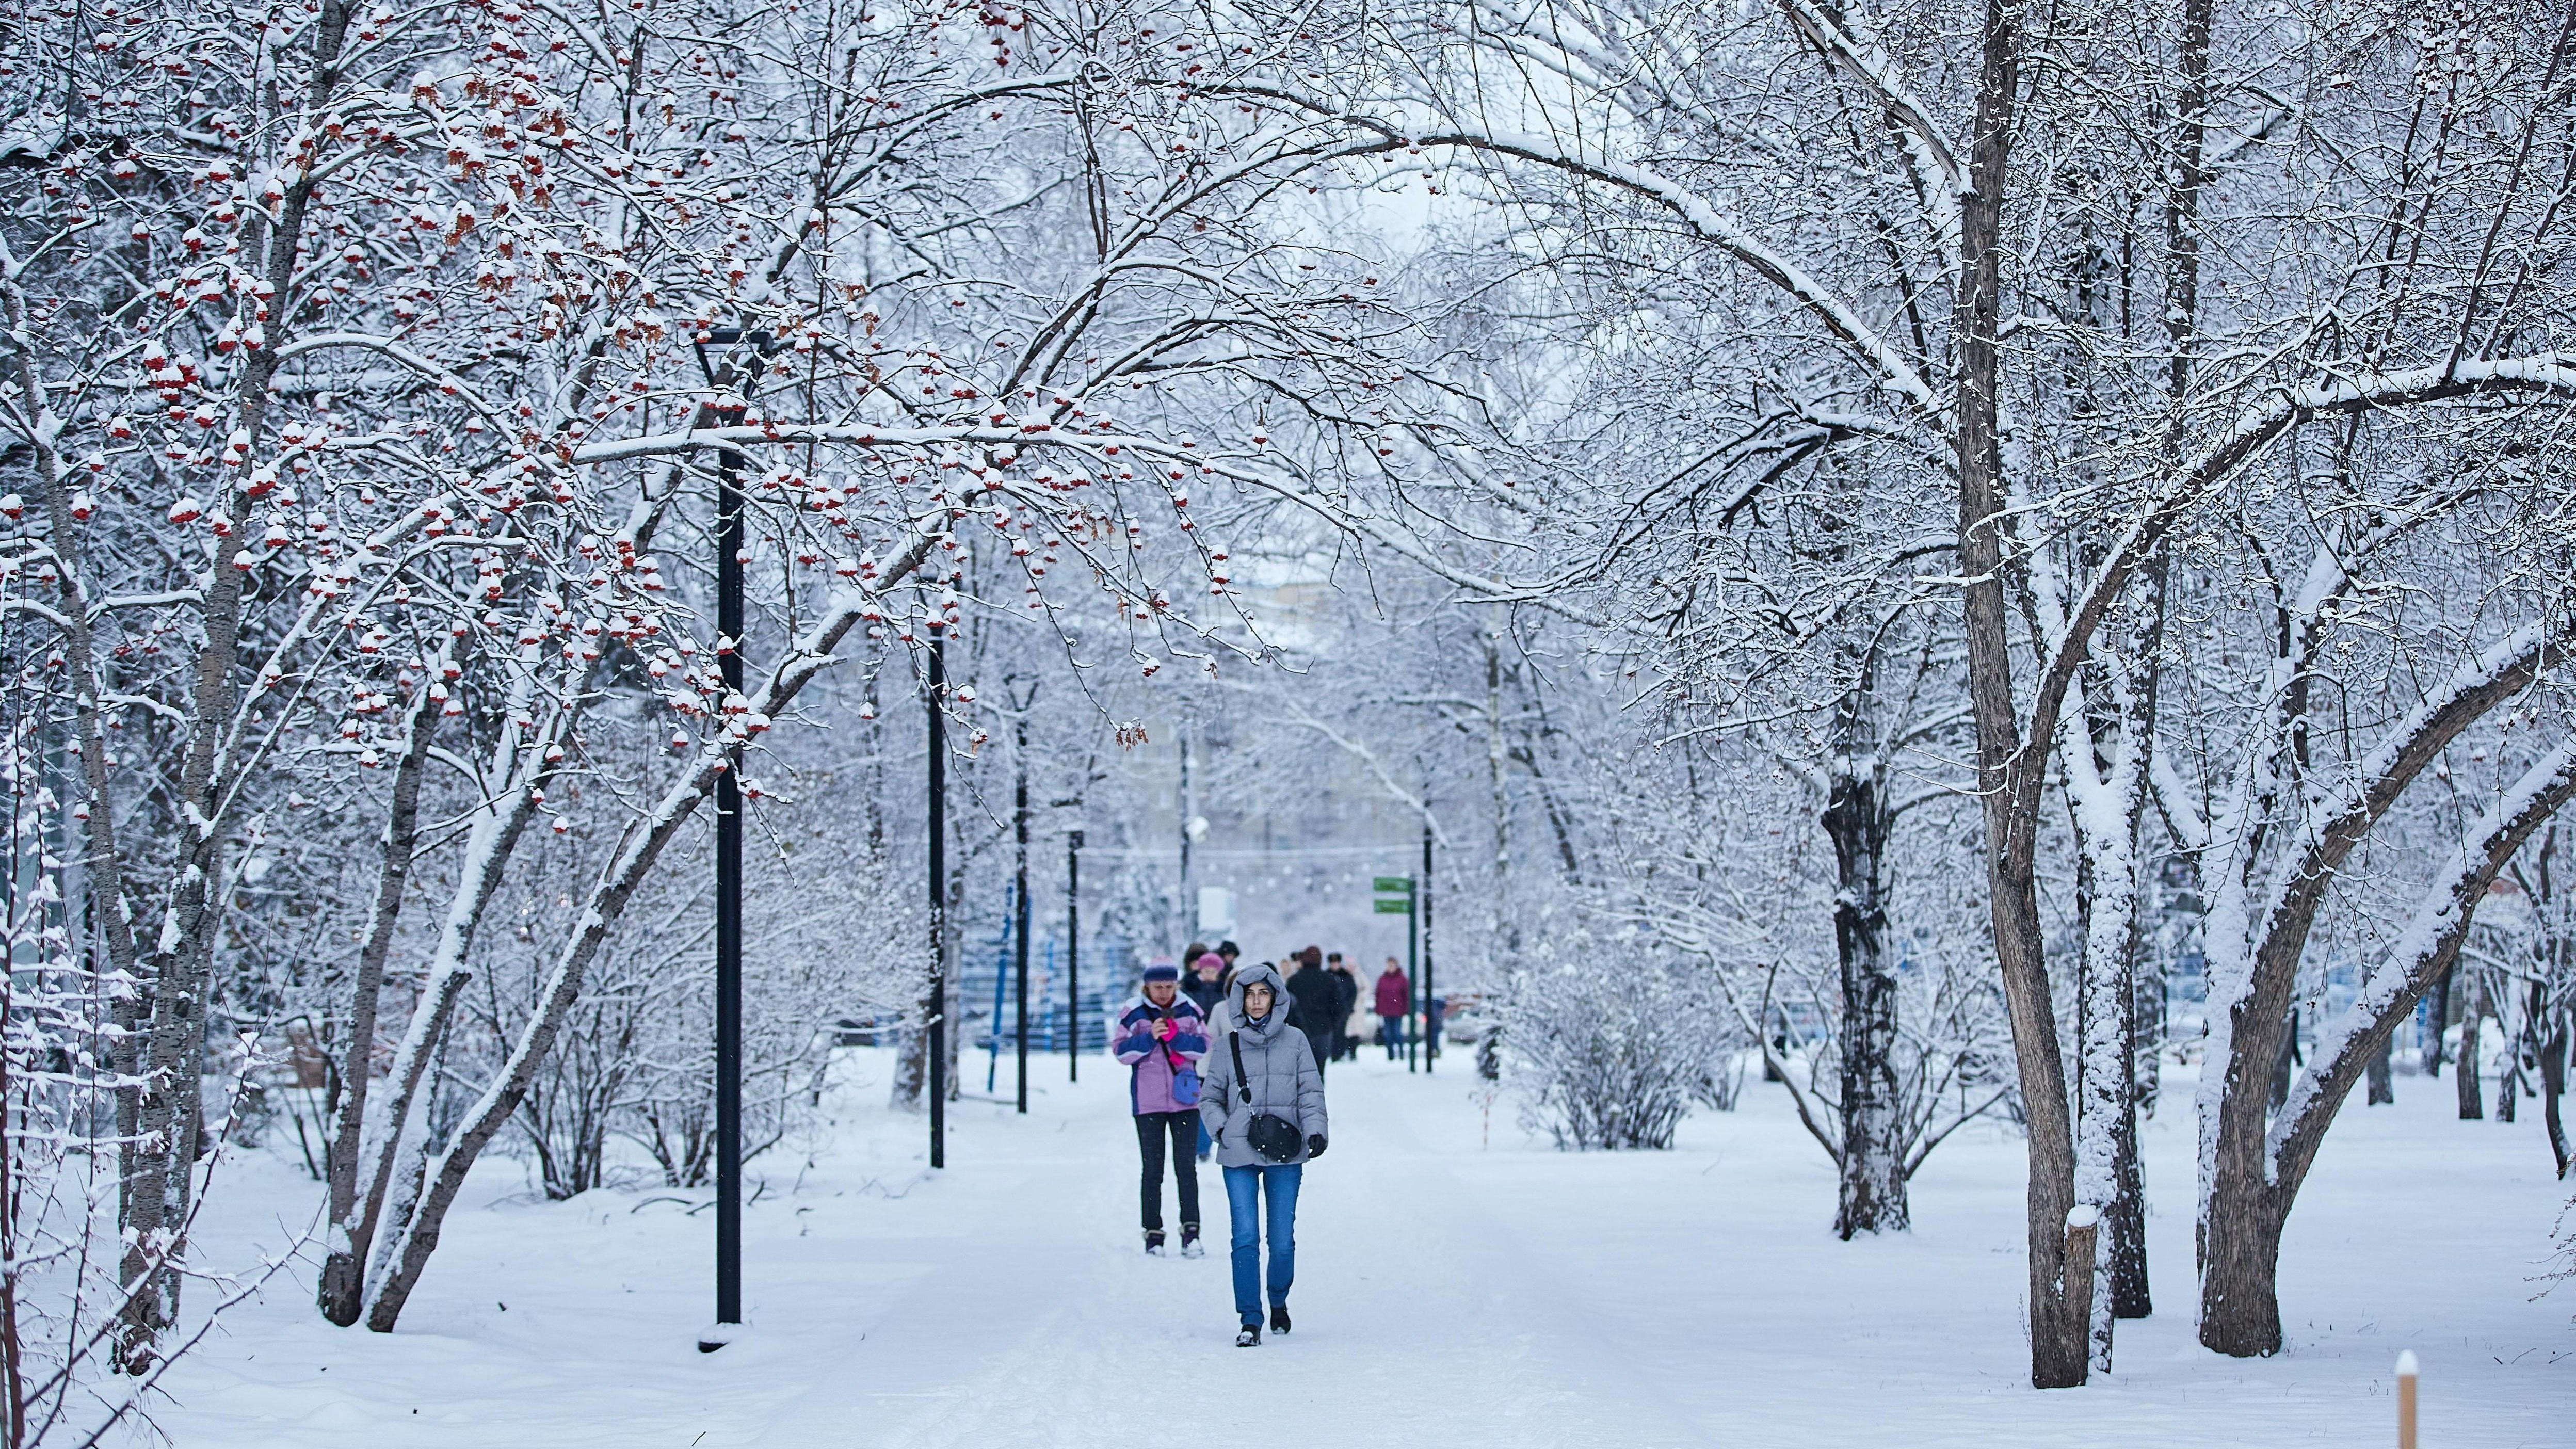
xmin=696 ymin=328 xmax=778 ymax=1354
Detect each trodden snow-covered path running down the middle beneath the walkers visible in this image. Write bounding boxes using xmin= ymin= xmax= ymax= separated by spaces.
xmin=747 ymin=1046 xmax=1698 ymax=1449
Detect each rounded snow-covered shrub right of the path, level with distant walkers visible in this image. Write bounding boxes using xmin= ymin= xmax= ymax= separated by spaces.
xmin=1502 ymin=939 xmax=1729 ymax=1152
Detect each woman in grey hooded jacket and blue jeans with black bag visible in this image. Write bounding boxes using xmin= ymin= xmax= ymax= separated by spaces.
xmin=1198 ymin=964 xmax=1329 ymax=1348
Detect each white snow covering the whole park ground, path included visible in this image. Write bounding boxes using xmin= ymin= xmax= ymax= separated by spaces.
xmin=160 ymin=1052 xmax=2576 ymax=1449
